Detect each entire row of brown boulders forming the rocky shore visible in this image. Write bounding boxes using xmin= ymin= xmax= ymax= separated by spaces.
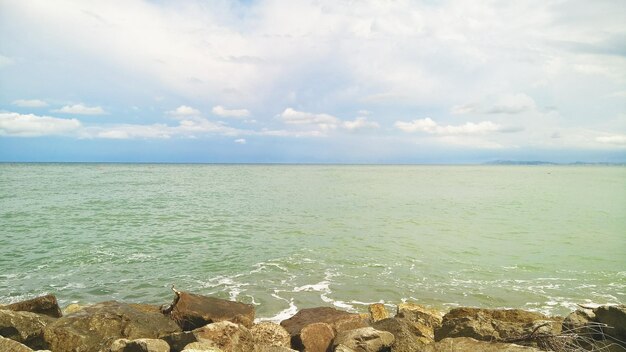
xmin=0 ymin=290 xmax=626 ymax=352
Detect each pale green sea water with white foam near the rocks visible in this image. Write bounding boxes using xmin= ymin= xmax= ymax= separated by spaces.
xmin=0 ymin=164 xmax=626 ymax=320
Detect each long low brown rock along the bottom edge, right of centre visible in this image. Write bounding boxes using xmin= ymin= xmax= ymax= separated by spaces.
xmin=420 ymin=337 xmax=541 ymax=352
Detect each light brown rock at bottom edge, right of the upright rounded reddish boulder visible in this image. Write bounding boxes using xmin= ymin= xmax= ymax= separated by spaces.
xmin=333 ymin=327 xmax=395 ymax=352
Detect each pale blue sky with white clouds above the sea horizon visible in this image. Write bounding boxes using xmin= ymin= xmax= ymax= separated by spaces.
xmin=0 ymin=0 xmax=626 ymax=163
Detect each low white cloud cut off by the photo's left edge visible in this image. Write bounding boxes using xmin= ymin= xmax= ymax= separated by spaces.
xmin=0 ymin=112 xmax=81 ymax=137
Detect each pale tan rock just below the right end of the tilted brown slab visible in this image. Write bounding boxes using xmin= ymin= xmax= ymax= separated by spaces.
xmin=193 ymin=321 xmax=254 ymax=352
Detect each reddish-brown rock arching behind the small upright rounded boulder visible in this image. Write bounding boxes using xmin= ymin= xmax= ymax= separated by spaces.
xmin=280 ymin=307 xmax=362 ymax=343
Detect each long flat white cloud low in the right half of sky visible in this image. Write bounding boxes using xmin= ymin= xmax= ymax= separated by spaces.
xmin=394 ymin=118 xmax=519 ymax=136
